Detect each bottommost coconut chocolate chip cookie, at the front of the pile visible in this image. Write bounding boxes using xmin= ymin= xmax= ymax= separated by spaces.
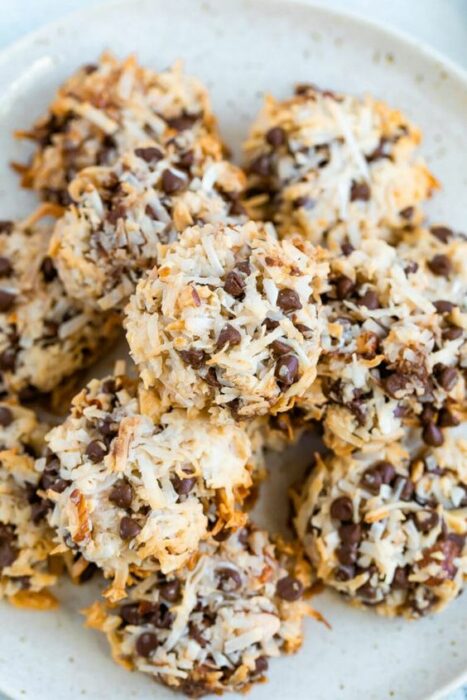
xmin=87 ymin=526 xmax=310 ymax=697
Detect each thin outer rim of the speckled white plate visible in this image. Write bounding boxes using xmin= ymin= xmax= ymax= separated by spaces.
xmin=0 ymin=0 xmax=467 ymax=700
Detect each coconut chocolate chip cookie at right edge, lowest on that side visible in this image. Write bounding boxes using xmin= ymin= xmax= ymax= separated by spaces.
xmin=295 ymin=434 xmax=467 ymax=617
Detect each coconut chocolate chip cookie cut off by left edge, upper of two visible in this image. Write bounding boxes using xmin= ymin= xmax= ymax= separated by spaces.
xmin=0 ymin=208 xmax=117 ymax=399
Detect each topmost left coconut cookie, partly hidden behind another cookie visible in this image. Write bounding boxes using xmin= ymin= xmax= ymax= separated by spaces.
xmin=17 ymin=53 xmax=216 ymax=204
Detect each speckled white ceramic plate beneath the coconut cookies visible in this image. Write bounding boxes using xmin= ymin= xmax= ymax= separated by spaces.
xmin=0 ymin=0 xmax=467 ymax=700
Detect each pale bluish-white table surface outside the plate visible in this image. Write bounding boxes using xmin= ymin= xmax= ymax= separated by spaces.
xmin=0 ymin=0 xmax=467 ymax=700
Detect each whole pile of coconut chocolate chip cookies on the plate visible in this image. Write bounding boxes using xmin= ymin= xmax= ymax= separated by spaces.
xmin=0 ymin=54 xmax=467 ymax=696
